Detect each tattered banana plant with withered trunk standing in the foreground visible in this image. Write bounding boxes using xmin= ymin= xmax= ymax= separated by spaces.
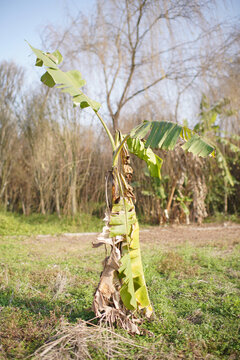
xmin=30 ymin=45 xmax=214 ymax=333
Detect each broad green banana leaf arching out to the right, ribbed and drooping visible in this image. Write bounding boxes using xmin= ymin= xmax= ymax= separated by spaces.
xmin=130 ymin=121 xmax=214 ymax=157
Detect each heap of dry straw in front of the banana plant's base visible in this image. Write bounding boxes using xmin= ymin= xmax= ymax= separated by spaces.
xmin=31 ymin=320 xmax=164 ymax=360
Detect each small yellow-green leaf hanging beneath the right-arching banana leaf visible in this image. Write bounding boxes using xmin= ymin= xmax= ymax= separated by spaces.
xmin=127 ymin=138 xmax=163 ymax=178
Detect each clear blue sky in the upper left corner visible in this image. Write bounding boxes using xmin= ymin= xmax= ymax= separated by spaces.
xmin=0 ymin=0 xmax=95 ymax=80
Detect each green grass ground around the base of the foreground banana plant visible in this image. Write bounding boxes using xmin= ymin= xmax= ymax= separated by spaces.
xmin=0 ymin=224 xmax=240 ymax=360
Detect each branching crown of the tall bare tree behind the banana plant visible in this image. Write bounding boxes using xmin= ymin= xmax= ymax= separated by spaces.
xmin=41 ymin=0 xmax=234 ymax=130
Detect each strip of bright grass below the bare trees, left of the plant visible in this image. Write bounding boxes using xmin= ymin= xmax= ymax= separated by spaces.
xmin=0 ymin=212 xmax=102 ymax=236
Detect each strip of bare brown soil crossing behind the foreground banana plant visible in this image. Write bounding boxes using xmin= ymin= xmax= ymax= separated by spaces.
xmin=31 ymin=223 xmax=240 ymax=251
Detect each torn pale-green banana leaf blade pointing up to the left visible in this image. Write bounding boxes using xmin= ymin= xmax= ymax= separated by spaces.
xmin=29 ymin=44 xmax=101 ymax=111
